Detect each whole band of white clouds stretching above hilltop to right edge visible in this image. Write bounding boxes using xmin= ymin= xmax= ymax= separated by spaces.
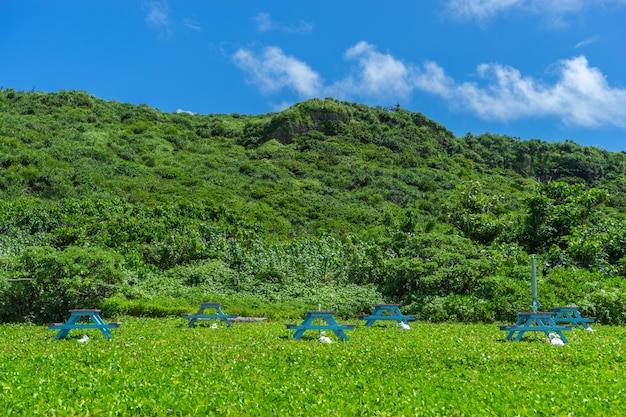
xmin=233 ymin=42 xmax=626 ymax=128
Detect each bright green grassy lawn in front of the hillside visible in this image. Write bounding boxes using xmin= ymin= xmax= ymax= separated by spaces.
xmin=0 ymin=318 xmax=626 ymax=416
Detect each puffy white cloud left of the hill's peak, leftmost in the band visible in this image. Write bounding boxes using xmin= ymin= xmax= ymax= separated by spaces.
xmin=233 ymin=47 xmax=321 ymax=98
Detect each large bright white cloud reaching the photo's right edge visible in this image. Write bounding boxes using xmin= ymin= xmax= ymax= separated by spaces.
xmin=416 ymin=56 xmax=626 ymax=128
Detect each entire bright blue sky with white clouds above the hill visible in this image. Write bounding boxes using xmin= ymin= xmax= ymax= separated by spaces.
xmin=0 ymin=0 xmax=626 ymax=151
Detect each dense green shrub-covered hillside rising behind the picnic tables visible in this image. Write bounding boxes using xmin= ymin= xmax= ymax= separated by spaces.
xmin=0 ymin=89 xmax=626 ymax=324
